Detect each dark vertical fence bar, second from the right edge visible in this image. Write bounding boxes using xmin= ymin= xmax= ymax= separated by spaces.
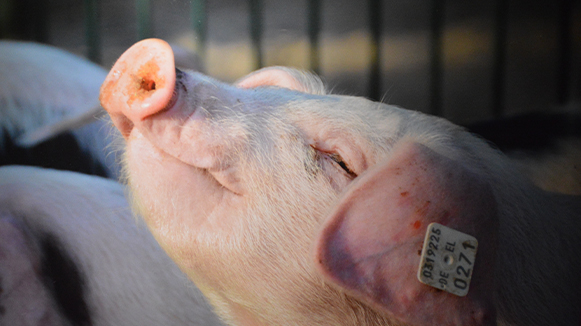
xmin=492 ymin=0 xmax=508 ymax=118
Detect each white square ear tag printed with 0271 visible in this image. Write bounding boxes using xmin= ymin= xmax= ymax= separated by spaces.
xmin=418 ymin=223 xmax=478 ymax=297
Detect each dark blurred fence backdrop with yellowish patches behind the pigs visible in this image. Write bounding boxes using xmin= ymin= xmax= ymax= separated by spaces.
xmin=0 ymin=0 xmax=581 ymax=124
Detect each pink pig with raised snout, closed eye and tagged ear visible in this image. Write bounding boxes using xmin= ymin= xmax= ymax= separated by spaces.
xmin=100 ymin=39 xmax=581 ymax=325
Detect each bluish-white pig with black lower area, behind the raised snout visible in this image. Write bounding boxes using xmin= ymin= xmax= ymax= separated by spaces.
xmin=0 ymin=40 xmax=120 ymax=178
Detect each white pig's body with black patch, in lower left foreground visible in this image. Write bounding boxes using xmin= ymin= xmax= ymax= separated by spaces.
xmin=0 ymin=166 xmax=222 ymax=326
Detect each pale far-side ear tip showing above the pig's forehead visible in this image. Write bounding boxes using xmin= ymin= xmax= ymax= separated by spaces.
xmin=235 ymin=67 xmax=325 ymax=95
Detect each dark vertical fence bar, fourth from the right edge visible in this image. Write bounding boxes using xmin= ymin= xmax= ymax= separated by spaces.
xmin=368 ymin=0 xmax=381 ymax=101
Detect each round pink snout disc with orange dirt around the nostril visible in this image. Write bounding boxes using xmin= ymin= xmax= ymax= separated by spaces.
xmin=100 ymin=40 xmax=176 ymax=137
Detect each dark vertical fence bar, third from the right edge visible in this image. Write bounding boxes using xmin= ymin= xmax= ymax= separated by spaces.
xmin=430 ymin=0 xmax=442 ymax=116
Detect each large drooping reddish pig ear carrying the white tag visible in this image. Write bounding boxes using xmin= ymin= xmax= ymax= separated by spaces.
xmin=315 ymin=142 xmax=498 ymax=325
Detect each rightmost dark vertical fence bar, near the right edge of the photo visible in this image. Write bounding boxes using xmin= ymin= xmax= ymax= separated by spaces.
xmin=557 ymin=0 xmax=573 ymax=105
